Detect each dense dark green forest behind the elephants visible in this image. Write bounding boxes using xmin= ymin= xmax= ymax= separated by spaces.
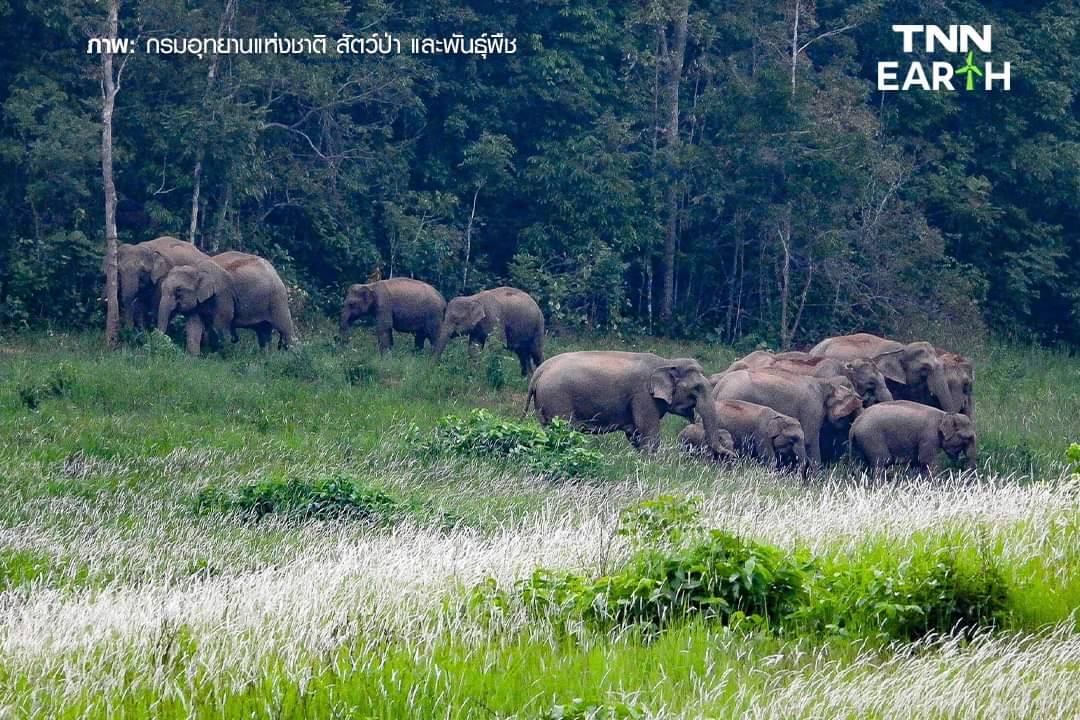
xmin=0 ymin=0 xmax=1080 ymax=347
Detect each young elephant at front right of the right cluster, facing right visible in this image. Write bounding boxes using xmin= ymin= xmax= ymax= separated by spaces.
xmin=850 ymin=400 xmax=976 ymax=472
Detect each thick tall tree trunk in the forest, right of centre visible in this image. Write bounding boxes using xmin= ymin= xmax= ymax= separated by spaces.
xmin=660 ymin=0 xmax=690 ymax=322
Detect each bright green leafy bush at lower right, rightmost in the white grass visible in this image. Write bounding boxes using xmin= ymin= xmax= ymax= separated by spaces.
xmin=797 ymin=547 xmax=1008 ymax=640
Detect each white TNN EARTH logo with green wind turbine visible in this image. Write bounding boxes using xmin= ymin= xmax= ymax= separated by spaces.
xmin=878 ymin=25 xmax=1012 ymax=91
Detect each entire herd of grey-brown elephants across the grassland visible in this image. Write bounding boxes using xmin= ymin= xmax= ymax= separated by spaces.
xmin=118 ymin=236 xmax=975 ymax=474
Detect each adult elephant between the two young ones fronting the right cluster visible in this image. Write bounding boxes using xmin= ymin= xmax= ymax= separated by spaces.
xmin=713 ymin=368 xmax=863 ymax=470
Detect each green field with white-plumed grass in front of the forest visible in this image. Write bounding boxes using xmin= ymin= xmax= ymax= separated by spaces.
xmin=0 ymin=328 xmax=1080 ymax=718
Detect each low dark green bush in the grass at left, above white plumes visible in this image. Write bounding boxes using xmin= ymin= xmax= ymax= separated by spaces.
xmin=195 ymin=474 xmax=416 ymax=524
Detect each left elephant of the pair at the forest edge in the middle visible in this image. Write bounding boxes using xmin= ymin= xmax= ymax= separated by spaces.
xmin=341 ymin=277 xmax=446 ymax=353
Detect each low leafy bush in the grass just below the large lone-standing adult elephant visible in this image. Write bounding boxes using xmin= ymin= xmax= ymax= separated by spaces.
xmin=409 ymin=409 xmax=605 ymax=479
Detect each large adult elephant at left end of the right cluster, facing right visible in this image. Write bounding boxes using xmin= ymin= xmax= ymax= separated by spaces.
xmin=525 ymin=351 xmax=732 ymax=457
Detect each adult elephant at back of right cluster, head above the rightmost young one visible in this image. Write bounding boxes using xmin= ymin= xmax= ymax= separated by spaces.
xmin=810 ymin=332 xmax=961 ymax=412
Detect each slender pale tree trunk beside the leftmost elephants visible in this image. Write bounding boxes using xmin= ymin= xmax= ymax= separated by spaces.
xmin=102 ymin=0 xmax=120 ymax=348
